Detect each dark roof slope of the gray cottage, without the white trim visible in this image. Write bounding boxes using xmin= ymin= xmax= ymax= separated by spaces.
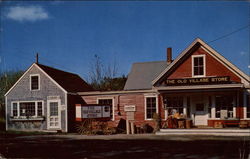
xmin=37 ymin=64 xmax=93 ymax=93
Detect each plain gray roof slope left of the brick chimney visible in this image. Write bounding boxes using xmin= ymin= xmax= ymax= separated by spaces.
xmin=124 ymin=61 xmax=167 ymax=90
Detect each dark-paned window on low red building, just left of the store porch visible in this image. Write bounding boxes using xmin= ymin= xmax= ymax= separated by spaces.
xmin=146 ymin=97 xmax=157 ymax=119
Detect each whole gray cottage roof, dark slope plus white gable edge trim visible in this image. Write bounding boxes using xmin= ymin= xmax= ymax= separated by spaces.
xmin=5 ymin=63 xmax=93 ymax=96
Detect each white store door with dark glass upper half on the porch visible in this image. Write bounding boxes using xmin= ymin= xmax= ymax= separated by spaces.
xmin=194 ymin=103 xmax=208 ymax=126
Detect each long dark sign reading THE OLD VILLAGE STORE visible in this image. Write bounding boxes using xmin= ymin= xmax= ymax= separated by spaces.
xmin=164 ymin=76 xmax=230 ymax=86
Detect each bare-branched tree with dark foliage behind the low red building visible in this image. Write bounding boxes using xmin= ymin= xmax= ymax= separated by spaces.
xmin=89 ymin=55 xmax=127 ymax=91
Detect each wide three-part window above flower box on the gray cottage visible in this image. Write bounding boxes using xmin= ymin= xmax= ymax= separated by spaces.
xmin=11 ymin=101 xmax=43 ymax=117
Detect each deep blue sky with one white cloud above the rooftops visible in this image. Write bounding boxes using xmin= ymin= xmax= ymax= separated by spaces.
xmin=0 ymin=1 xmax=250 ymax=80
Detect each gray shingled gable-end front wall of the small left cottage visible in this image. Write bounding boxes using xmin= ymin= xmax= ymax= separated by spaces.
xmin=7 ymin=66 xmax=66 ymax=131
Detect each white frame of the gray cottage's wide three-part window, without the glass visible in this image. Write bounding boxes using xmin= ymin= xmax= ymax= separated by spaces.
xmin=10 ymin=100 xmax=44 ymax=119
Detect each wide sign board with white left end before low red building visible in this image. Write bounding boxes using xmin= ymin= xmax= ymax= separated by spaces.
xmin=76 ymin=105 xmax=111 ymax=119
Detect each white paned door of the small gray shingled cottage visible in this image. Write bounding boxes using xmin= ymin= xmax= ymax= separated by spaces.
xmin=47 ymin=100 xmax=61 ymax=129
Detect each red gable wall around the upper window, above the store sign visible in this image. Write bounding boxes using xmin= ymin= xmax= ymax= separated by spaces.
xmin=168 ymin=47 xmax=241 ymax=82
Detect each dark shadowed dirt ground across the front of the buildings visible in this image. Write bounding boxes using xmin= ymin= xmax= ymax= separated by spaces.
xmin=0 ymin=133 xmax=250 ymax=159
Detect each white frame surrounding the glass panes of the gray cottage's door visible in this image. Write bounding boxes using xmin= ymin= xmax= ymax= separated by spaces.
xmin=47 ymin=99 xmax=62 ymax=130
